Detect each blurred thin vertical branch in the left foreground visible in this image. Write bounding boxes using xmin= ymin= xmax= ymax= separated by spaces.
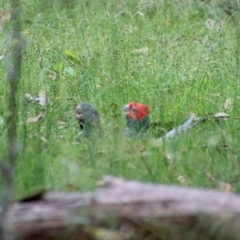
xmin=0 ymin=0 xmax=23 ymax=239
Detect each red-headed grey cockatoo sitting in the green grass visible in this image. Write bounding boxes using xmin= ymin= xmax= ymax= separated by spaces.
xmin=123 ymin=102 xmax=150 ymax=136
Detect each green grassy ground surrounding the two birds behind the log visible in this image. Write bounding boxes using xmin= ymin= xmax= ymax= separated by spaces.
xmin=0 ymin=0 xmax=240 ymax=197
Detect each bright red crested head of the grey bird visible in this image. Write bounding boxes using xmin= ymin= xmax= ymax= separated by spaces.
xmin=123 ymin=102 xmax=150 ymax=121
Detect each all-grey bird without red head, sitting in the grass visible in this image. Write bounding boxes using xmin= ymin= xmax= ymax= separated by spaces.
xmin=76 ymin=102 xmax=103 ymax=137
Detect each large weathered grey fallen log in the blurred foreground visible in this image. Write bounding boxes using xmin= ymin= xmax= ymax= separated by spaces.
xmin=7 ymin=177 xmax=240 ymax=240
